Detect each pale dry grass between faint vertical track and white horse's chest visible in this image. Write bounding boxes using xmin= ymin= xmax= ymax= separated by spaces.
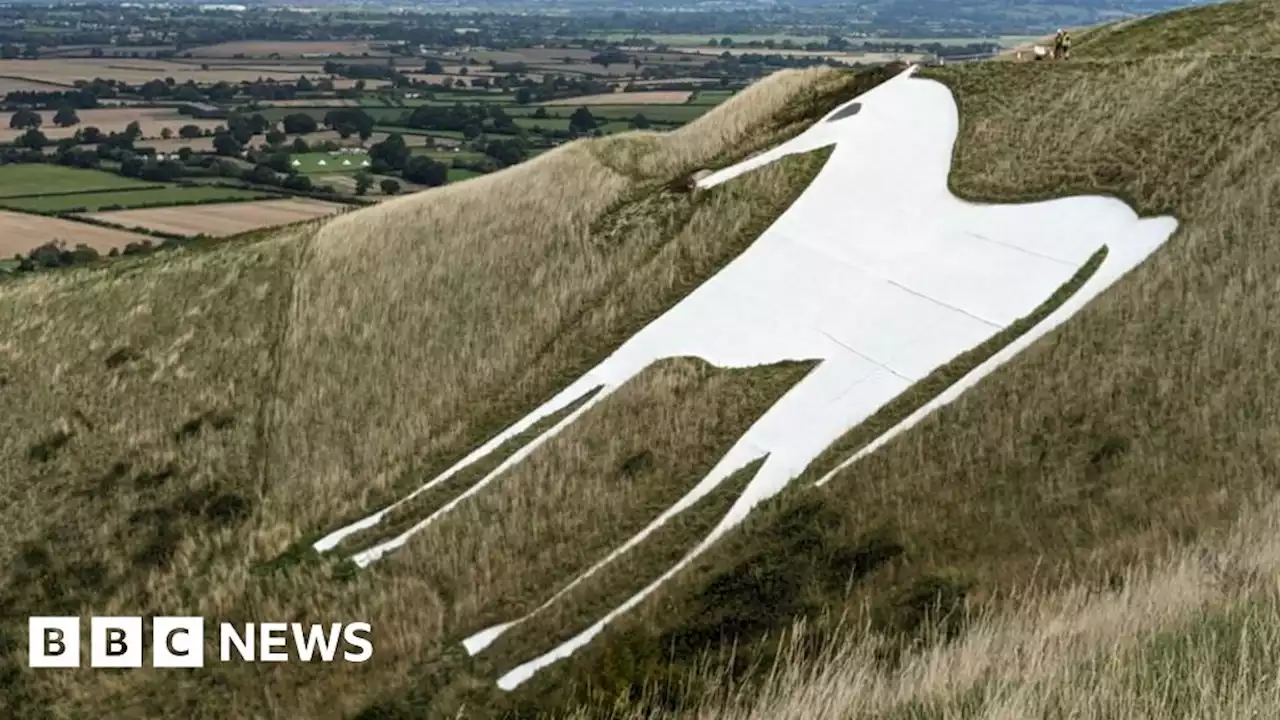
xmin=264 ymin=72 xmax=855 ymax=540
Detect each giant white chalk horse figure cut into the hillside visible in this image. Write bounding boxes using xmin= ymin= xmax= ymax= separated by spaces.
xmin=316 ymin=68 xmax=1176 ymax=689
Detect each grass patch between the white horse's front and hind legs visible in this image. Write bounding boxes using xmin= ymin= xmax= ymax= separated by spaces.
xmin=360 ymin=359 xmax=808 ymax=655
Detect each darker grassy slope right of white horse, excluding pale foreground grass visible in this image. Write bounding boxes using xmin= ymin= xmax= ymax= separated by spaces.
xmin=504 ymin=32 xmax=1280 ymax=712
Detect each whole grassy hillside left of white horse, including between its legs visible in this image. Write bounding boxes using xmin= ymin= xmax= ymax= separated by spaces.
xmin=0 ymin=63 xmax=891 ymax=719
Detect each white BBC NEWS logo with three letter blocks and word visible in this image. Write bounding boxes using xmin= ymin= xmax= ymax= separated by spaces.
xmin=27 ymin=616 xmax=374 ymax=667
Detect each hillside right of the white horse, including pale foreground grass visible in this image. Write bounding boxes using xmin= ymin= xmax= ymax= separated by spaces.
xmin=524 ymin=3 xmax=1280 ymax=717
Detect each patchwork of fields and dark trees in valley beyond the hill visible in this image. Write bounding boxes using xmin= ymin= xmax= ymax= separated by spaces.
xmin=0 ymin=23 xmax=764 ymax=254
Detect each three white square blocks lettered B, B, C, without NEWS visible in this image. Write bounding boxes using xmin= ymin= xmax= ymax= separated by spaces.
xmin=27 ymin=618 xmax=205 ymax=667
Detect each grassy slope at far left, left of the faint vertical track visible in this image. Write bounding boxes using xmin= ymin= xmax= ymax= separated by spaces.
xmin=0 ymin=224 xmax=312 ymax=717
